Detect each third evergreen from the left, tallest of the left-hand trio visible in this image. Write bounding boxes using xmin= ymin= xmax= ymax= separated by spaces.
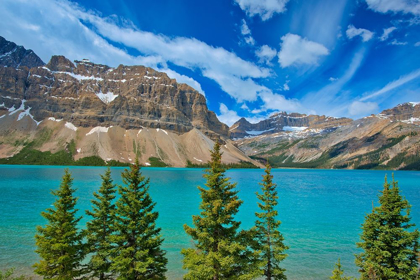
xmin=111 ymin=160 xmax=167 ymax=280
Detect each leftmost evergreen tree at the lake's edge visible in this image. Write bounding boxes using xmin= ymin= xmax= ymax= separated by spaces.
xmin=34 ymin=170 xmax=85 ymax=280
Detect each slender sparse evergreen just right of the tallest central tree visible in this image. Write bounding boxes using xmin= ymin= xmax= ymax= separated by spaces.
xmin=254 ymin=164 xmax=288 ymax=280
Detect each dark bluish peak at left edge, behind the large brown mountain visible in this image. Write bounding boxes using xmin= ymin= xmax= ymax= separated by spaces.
xmin=0 ymin=36 xmax=45 ymax=68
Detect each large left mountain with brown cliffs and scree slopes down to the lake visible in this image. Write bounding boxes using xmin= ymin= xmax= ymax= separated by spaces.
xmin=0 ymin=36 xmax=259 ymax=166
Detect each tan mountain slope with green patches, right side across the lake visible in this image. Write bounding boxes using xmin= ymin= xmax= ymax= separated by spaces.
xmin=230 ymin=102 xmax=420 ymax=170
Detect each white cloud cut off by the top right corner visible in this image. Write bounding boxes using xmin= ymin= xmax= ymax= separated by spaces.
xmin=366 ymin=0 xmax=420 ymax=15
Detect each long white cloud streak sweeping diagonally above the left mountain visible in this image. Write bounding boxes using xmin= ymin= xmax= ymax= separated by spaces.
xmin=0 ymin=0 xmax=271 ymax=104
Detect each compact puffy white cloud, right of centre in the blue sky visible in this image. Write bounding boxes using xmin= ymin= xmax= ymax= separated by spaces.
xmin=278 ymin=33 xmax=329 ymax=68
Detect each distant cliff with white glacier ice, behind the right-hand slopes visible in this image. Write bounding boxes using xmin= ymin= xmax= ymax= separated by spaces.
xmin=229 ymin=112 xmax=352 ymax=138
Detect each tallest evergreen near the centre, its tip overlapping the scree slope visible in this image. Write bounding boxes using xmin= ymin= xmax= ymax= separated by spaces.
xmin=182 ymin=143 xmax=259 ymax=280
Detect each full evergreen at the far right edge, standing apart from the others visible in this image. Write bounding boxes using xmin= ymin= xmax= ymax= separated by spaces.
xmin=356 ymin=176 xmax=419 ymax=279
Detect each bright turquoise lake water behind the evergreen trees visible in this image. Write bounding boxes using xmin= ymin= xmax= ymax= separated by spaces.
xmin=0 ymin=166 xmax=420 ymax=279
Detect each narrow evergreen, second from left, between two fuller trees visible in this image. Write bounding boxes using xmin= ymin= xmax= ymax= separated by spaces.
xmin=86 ymin=167 xmax=116 ymax=280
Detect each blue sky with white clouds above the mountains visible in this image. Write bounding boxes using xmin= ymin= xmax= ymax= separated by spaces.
xmin=0 ymin=0 xmax=420 ymax=125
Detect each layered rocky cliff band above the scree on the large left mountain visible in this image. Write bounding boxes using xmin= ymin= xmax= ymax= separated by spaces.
xmin=0 ymin=56 xmax=228 ymax=137
